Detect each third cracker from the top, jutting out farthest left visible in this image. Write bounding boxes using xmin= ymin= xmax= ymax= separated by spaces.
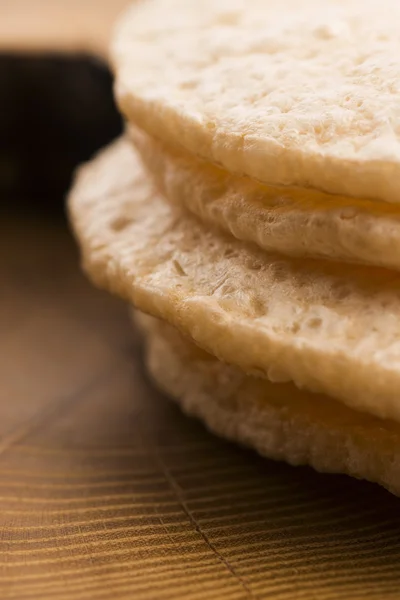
xmin=70 ymin=140 xmax=400 ymax=420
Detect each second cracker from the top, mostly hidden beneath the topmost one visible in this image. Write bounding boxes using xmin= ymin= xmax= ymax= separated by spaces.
xmin=130 ymin=127 xmax=400 ymax=269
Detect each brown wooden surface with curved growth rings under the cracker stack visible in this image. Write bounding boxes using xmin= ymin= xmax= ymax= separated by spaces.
xmin=0 ymin=217 xmax=400 ymax=600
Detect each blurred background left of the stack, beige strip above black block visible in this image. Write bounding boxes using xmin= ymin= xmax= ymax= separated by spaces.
xmin=0 ymin=0 xmax=134 ymax=214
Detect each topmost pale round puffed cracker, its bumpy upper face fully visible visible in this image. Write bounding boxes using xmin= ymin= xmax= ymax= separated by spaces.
xmin=112 ymin=0 xmax=400 ymax=202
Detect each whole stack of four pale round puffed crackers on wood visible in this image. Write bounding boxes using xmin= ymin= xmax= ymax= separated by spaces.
xmin=69 ymin=0 xmax=400 ymax=494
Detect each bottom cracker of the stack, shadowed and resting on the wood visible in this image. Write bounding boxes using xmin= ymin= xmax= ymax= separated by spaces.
xmin=136 ymin=315 xmax=400 ymax=495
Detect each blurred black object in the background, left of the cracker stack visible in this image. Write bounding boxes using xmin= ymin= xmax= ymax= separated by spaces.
xmin=0 ymin=55 xmax=122 ymax=213
